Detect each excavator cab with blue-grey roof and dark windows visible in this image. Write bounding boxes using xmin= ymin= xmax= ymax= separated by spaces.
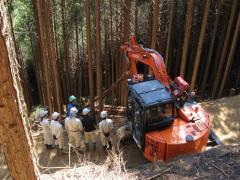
xmin=127 ymin=80 xmax=175 ymax=150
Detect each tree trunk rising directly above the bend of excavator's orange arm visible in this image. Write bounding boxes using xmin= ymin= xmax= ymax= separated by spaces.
xmin=151 ymin=0 xmax=160 ymax=49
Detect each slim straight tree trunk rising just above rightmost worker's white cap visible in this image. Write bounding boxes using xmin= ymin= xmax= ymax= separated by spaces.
xmin=95 ymin=0 xmax=103 ymax=113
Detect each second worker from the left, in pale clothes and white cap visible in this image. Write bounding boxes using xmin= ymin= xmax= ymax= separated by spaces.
xmin=50 ymin=112 xmax=64 ymax=153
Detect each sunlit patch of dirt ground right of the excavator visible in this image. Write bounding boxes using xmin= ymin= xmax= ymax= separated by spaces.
xmin=201 ymin=95 xmax=240 ymax=144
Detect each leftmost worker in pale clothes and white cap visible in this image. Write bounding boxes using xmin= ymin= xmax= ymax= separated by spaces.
xmin=39 ymin=110 xmax=53 ymax=149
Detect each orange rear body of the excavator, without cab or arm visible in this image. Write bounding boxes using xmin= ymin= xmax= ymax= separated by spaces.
xmin=144 ymin=104 xmax=210 ymax=161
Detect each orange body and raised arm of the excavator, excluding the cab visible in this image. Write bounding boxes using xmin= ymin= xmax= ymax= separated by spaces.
xmin=121 ymin=37 xmax=210 ymax=161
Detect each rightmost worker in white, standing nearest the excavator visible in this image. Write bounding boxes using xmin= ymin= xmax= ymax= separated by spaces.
xmin=99 ymin=111 xmax=113 ymax=150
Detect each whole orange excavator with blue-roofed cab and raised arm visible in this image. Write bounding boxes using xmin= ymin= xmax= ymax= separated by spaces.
xmin=121 ymin=36 xmax=219 ymax=161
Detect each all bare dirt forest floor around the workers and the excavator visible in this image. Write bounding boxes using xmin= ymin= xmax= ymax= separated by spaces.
xmin=0 ymin=96 xmax=240 ymax=179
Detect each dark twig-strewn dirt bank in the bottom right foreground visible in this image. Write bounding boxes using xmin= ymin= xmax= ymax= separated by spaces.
xmin=138 ymin=145 xmax=240 ymax=180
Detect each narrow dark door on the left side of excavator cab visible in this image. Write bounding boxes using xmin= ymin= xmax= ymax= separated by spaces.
xmin=132 ymin=101 xmax=144 ymax=149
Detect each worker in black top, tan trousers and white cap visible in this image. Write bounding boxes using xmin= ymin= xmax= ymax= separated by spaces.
xmin=82 ymin=108 xmax=96 ymax=149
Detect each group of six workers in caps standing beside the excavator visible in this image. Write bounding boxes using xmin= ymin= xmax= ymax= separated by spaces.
xmin=39 ymin=96 xmax=113 ymax=152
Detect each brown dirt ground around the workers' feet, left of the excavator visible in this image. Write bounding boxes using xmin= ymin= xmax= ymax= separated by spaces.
xmin=33 ymin=116 xmax=148 ymax=173
